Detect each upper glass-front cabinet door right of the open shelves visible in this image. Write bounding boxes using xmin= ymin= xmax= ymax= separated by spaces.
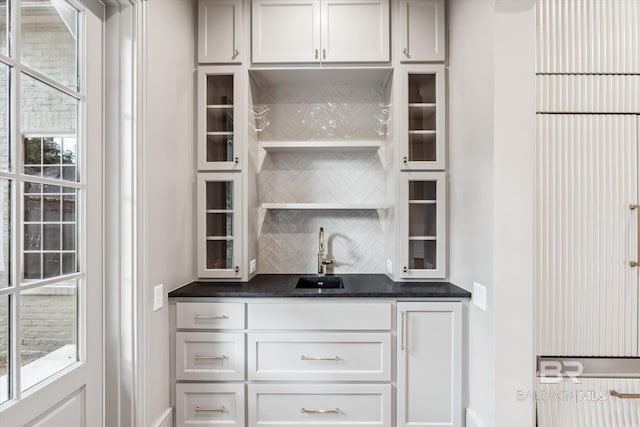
xmin=400 ymin=65 xmax=447 ymax=170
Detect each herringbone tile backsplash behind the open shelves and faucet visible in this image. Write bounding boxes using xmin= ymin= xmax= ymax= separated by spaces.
xmin=250 ymin=80 xmax=389 ymax=274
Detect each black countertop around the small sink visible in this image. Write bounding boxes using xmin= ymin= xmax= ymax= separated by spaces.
xmin=169 ymin=274 xmax=471 ymax=298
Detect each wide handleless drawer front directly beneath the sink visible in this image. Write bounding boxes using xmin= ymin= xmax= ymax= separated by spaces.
xmin=247 ymin=302 xmax=391 ymax=331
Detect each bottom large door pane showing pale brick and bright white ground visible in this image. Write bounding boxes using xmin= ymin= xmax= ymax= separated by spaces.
xmin=20 ymin=281 xmax=78 ymax=391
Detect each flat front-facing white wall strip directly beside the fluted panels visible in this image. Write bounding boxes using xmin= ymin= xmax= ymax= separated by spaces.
xmin=494 ymin=0 xmax=536 ymax=427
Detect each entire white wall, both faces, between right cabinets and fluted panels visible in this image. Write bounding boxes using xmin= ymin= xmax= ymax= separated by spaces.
xmin=447 ymin=0 xmax=535 ymax=427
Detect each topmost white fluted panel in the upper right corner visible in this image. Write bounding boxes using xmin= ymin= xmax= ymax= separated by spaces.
xmin=536 ymin=0 xmax=640 ymax=73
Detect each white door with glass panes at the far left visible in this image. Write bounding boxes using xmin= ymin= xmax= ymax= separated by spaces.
xmin=0 ymin=0 xmax=103 ymax=426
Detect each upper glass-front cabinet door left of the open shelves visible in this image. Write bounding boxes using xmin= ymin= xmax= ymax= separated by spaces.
xmin=197 ymin=67 xmax=242 ymax=171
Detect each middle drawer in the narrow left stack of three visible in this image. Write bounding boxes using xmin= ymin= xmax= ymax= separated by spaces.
xmin=176 ymin=332 xmax=244 ymax=380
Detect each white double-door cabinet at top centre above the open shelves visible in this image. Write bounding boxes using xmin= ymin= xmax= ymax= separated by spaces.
xmin=252 ymin=0 xmax=389 ymax=63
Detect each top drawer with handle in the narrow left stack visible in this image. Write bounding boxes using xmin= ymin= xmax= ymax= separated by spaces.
xmin=176 ymin=302 xmax=244 ymax=329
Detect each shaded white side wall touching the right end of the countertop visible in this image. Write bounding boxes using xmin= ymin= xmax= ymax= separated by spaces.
xmin=447 ymin=0 xmax=494 ymax=426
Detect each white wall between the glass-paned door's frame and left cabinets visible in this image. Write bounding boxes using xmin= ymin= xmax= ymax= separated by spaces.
xmin=140 ymin=0 xmax=196 ymax=426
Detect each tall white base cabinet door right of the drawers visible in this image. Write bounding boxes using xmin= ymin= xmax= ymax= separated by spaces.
xmin=397 ymin=302 xmax=462 ymax=427
